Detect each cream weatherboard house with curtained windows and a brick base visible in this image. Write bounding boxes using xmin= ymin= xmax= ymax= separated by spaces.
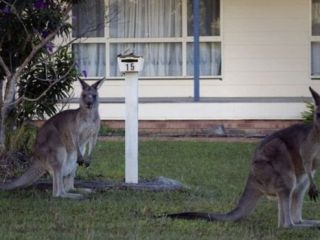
xmin=72 ymin=0 xmax=320 ymax=134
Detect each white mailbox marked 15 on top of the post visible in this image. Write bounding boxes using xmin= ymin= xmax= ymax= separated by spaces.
xmin=118 ymin=54 xmax=143 ymax=73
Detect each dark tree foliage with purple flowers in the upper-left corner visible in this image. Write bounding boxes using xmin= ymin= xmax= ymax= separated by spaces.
xmin=0 ymin=0 xmax=73 ymax=80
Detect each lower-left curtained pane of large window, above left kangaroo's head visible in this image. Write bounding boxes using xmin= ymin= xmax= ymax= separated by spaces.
xmin=72 ymin=43 xmax=106 ymax=77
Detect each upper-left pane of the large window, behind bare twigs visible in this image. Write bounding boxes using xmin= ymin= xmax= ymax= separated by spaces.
xmin=72 ymin=0 xmax=105 ymax=37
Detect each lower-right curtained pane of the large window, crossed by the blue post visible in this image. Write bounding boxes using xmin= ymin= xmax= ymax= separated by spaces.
xmin=187 ymin=42 xmax=221 ymax=76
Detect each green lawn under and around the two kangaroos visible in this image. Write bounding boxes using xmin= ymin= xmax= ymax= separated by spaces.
xmin=0 ymin=141 xmax=320 ymax=240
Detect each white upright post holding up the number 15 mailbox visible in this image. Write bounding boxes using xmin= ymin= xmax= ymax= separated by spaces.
xmin=125 ymin=72 xmax=138 ymax=183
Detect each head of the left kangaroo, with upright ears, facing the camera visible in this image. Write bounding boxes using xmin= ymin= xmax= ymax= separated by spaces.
xmin=79 ymin=78 xmax=104 ymax=109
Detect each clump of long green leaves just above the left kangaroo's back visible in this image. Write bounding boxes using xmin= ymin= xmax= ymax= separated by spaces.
xmin=16 ymin=49 xmax=77 ymax=124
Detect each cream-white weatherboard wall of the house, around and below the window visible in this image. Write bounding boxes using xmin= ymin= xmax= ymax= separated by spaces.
xmin=71 ymin=0 xmax=320 ymax=120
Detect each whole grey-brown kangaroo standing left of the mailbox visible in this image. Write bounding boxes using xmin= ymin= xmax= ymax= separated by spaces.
xmin=0 ymin=78 xmax=104 ymax=199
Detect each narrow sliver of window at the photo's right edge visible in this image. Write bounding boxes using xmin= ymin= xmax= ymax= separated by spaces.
xmin=311 ymin=0 xmax=320 ymax=78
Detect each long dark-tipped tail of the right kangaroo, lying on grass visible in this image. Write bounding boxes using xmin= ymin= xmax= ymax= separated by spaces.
xmin=165 ymin=176 xmax=262 ymax=221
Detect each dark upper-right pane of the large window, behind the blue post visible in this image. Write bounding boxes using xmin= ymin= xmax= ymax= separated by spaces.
xmin=188 ymin=0 xmax=220 ymax=36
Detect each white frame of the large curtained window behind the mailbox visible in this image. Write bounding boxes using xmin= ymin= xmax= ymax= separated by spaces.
xmin=73 ymin=0 xmax=224 ymax=80
